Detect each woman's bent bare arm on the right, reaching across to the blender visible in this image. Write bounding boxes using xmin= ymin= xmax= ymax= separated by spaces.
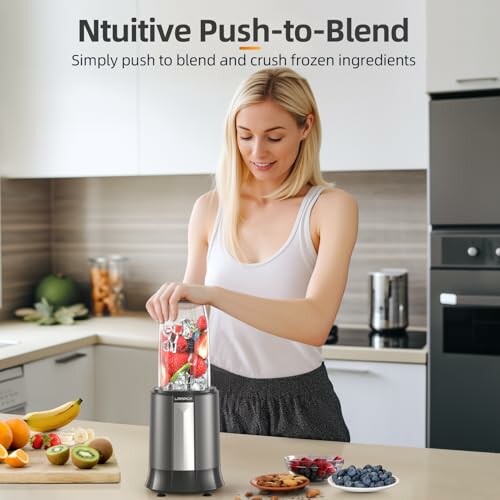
xmin=148 ymin=189 xmax=358 ymax=346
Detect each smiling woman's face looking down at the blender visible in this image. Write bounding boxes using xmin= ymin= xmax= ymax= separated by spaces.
xmin=236 ymin=100 xmax=312 ymax=182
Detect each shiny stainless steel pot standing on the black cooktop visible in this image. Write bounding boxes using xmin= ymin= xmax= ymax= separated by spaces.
xmin=370 ymin=269 xmax=408 ymax=332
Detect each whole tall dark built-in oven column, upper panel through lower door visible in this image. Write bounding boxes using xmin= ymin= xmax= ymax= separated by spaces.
xmin=427 ymin=90 xmax=500 ymax=452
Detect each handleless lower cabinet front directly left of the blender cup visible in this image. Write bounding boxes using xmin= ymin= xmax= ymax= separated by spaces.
xmin=95 ymin=345 xmax=158 ymax=424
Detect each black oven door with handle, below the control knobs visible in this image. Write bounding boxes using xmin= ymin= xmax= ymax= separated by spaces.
xmin=428 ymin=269 xmax=500 ymax=452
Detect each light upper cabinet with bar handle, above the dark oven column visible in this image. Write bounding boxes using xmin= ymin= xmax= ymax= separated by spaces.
xmin=427 ymin=0 xmax=500 ymax=92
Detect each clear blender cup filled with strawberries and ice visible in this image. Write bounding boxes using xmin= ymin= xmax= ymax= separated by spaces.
xmin=158 ymin=301 xmax=210 ymax=391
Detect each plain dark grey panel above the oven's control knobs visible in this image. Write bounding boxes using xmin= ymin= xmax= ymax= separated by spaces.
xmin=429 ymin=91 xmax=500 ymax=226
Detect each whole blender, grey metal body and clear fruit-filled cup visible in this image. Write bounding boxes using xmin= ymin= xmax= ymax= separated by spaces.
xmin=146 ymin=301 xmax=223 ymax=494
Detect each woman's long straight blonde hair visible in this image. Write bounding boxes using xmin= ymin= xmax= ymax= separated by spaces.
xmin=215 ymin=68 xmax=331 ymax=257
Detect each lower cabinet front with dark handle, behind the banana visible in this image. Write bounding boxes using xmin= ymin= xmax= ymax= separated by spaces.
xmin=24 ymin=346 xmax=95 ymax=420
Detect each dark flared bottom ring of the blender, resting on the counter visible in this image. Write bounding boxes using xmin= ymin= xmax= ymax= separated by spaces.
xmin=146 ymin=467 xmax=223 ymax=494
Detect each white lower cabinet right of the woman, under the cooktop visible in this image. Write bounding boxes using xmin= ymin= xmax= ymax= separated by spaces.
xmin=325 ymin=360 xmax=426 ymax=447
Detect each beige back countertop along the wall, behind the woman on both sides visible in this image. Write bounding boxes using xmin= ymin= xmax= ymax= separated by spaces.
xmin=0 ymin=312 xmax=427 ymax=370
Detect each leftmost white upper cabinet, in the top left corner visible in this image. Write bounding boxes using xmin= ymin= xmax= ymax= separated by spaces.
xmin=0 ymin=0 xmax=138 ymax=177
